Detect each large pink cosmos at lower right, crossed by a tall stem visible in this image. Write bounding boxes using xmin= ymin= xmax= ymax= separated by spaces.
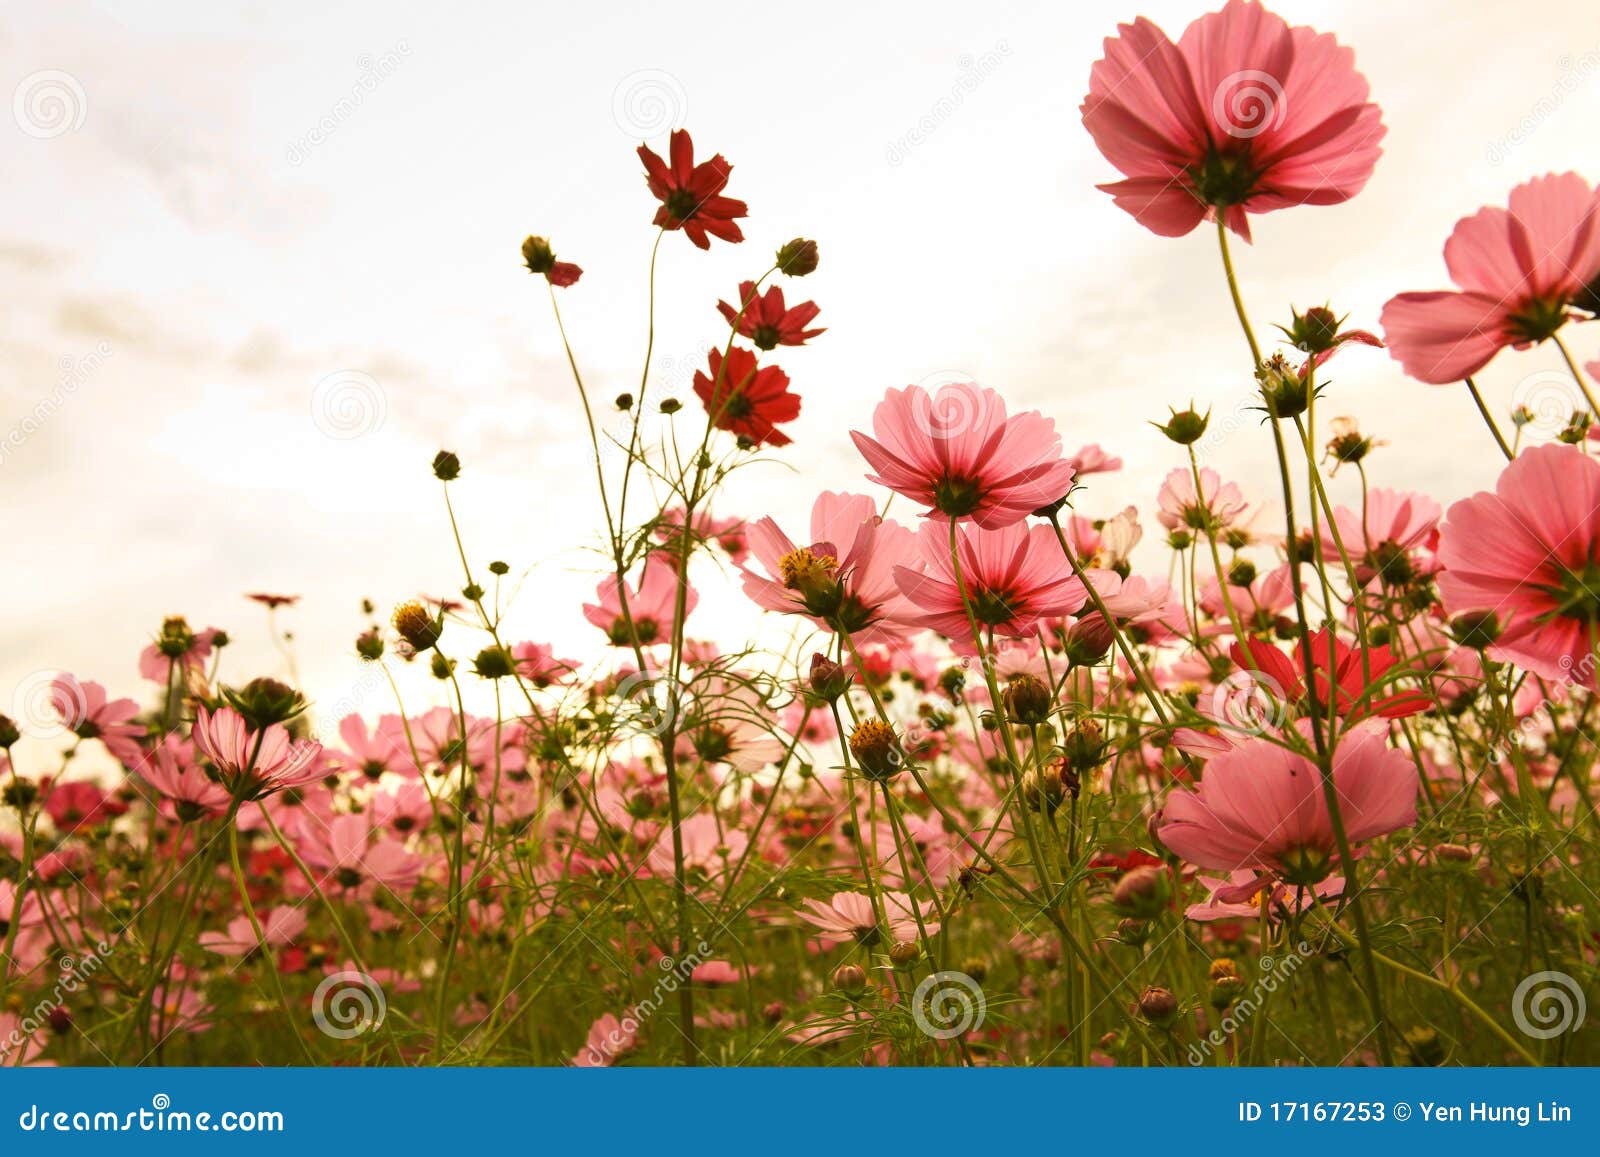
xmin=1157 ymin=722 xmax=1418 ymax=885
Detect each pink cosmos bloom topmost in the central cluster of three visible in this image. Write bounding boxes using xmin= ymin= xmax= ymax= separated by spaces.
xmin=850 ymin=382 xmax=1072 ymax=530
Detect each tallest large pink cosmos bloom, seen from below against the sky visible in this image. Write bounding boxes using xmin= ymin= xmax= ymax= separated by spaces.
xmin=1080 ymin=0 xmax=1384 ymax=240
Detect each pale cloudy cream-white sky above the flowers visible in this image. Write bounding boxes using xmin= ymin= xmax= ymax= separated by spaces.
xmin=0 ymin=0 xmax=1600 ymax=768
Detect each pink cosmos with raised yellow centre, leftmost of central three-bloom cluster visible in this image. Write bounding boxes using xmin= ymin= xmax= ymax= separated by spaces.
xmin=739 ymin=491 xmax=912 ymax=643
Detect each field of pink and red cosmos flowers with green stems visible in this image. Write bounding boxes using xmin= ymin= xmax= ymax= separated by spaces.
xmin=0 ymin=0 xmax=1600 ymax=1079
